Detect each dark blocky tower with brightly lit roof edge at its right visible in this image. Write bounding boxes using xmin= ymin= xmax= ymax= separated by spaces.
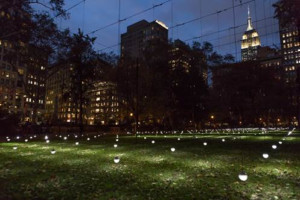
xmin=121 ymin=20 xmax=168 ymax=58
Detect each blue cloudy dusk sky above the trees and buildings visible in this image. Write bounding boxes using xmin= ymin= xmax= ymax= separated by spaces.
xmin=48 ymin=0 xmax=280 ymax=60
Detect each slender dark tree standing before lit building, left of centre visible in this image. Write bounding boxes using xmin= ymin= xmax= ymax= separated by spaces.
xmin=58 ymin=30 xmax=97 ymax=132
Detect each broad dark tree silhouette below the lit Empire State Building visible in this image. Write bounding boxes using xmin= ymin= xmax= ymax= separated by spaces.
xmin=210 ymin=61 xmax=290 ymax=126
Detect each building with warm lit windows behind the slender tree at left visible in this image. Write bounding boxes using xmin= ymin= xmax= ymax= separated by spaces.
xmin=46 ymin=65 xmax=119 ymax=125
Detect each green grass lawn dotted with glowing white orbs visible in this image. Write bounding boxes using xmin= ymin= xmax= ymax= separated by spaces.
xmin=0 ymin=135 xmax=300 ymax=200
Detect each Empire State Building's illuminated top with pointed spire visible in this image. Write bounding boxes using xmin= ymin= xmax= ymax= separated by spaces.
xmin=241 ymin=8 xmax=261 ymax=61
